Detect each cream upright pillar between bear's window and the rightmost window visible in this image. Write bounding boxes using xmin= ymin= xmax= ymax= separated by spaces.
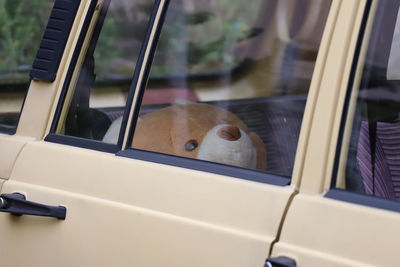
xmin=300 ymin=1 xmax=366 ymax=194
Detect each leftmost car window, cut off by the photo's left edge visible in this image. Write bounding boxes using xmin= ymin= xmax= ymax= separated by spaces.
xmin=0 ymin=0 xmax=54 ymax=131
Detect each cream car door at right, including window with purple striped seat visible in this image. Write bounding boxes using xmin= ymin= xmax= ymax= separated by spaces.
xmin=272 ymin=1 xmax=400 ymax=266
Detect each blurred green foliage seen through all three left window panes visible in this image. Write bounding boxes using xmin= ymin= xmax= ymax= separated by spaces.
xmin=0 ymin=0 xmax=263 ymax=80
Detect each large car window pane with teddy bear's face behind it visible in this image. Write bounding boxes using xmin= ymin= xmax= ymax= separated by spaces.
xmin=118 ymin=0 xmax=331 ymax=180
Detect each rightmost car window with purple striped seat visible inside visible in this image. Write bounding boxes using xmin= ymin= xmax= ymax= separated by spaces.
xmin=336 ymin=0 xmax=400 ymax=201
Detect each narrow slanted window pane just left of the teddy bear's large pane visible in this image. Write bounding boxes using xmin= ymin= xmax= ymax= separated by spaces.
xmin=55 ymin=0 xmax=153 ymax=144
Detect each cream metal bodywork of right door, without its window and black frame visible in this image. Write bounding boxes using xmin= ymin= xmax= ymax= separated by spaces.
xmin=272 ymin=1 xmax=400 ymax=266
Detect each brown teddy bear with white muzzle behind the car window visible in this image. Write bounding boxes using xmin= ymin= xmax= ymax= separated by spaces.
xmin=103 ymin=102 xmax=266 ymax=170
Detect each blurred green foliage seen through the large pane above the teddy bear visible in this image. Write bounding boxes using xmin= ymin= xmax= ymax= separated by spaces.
xmin=148 ymin=0 xmax=263 ymax=76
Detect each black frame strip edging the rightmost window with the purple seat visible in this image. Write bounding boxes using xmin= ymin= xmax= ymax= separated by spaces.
xmin=324 ymin=0 xmax=400 ymax=212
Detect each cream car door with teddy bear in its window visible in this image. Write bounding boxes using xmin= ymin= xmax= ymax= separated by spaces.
xmin=0 ymin=0 xmax=332 ymax=266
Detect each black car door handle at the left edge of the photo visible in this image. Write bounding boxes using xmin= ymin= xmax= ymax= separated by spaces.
xmin=0 ymin=193 xmax=67 ymax=220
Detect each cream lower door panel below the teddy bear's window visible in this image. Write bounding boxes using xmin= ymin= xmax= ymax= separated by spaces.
xmin=0 ymin=142 xmax=293 ymax=266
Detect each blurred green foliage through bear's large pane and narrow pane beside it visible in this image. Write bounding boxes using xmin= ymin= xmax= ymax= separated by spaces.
xmin=95 ymin=0 xmax=264 ymax=78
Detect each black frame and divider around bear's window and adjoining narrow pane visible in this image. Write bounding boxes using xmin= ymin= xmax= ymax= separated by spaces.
xmin=44 ymin=0 xmax=332 ymax=186
